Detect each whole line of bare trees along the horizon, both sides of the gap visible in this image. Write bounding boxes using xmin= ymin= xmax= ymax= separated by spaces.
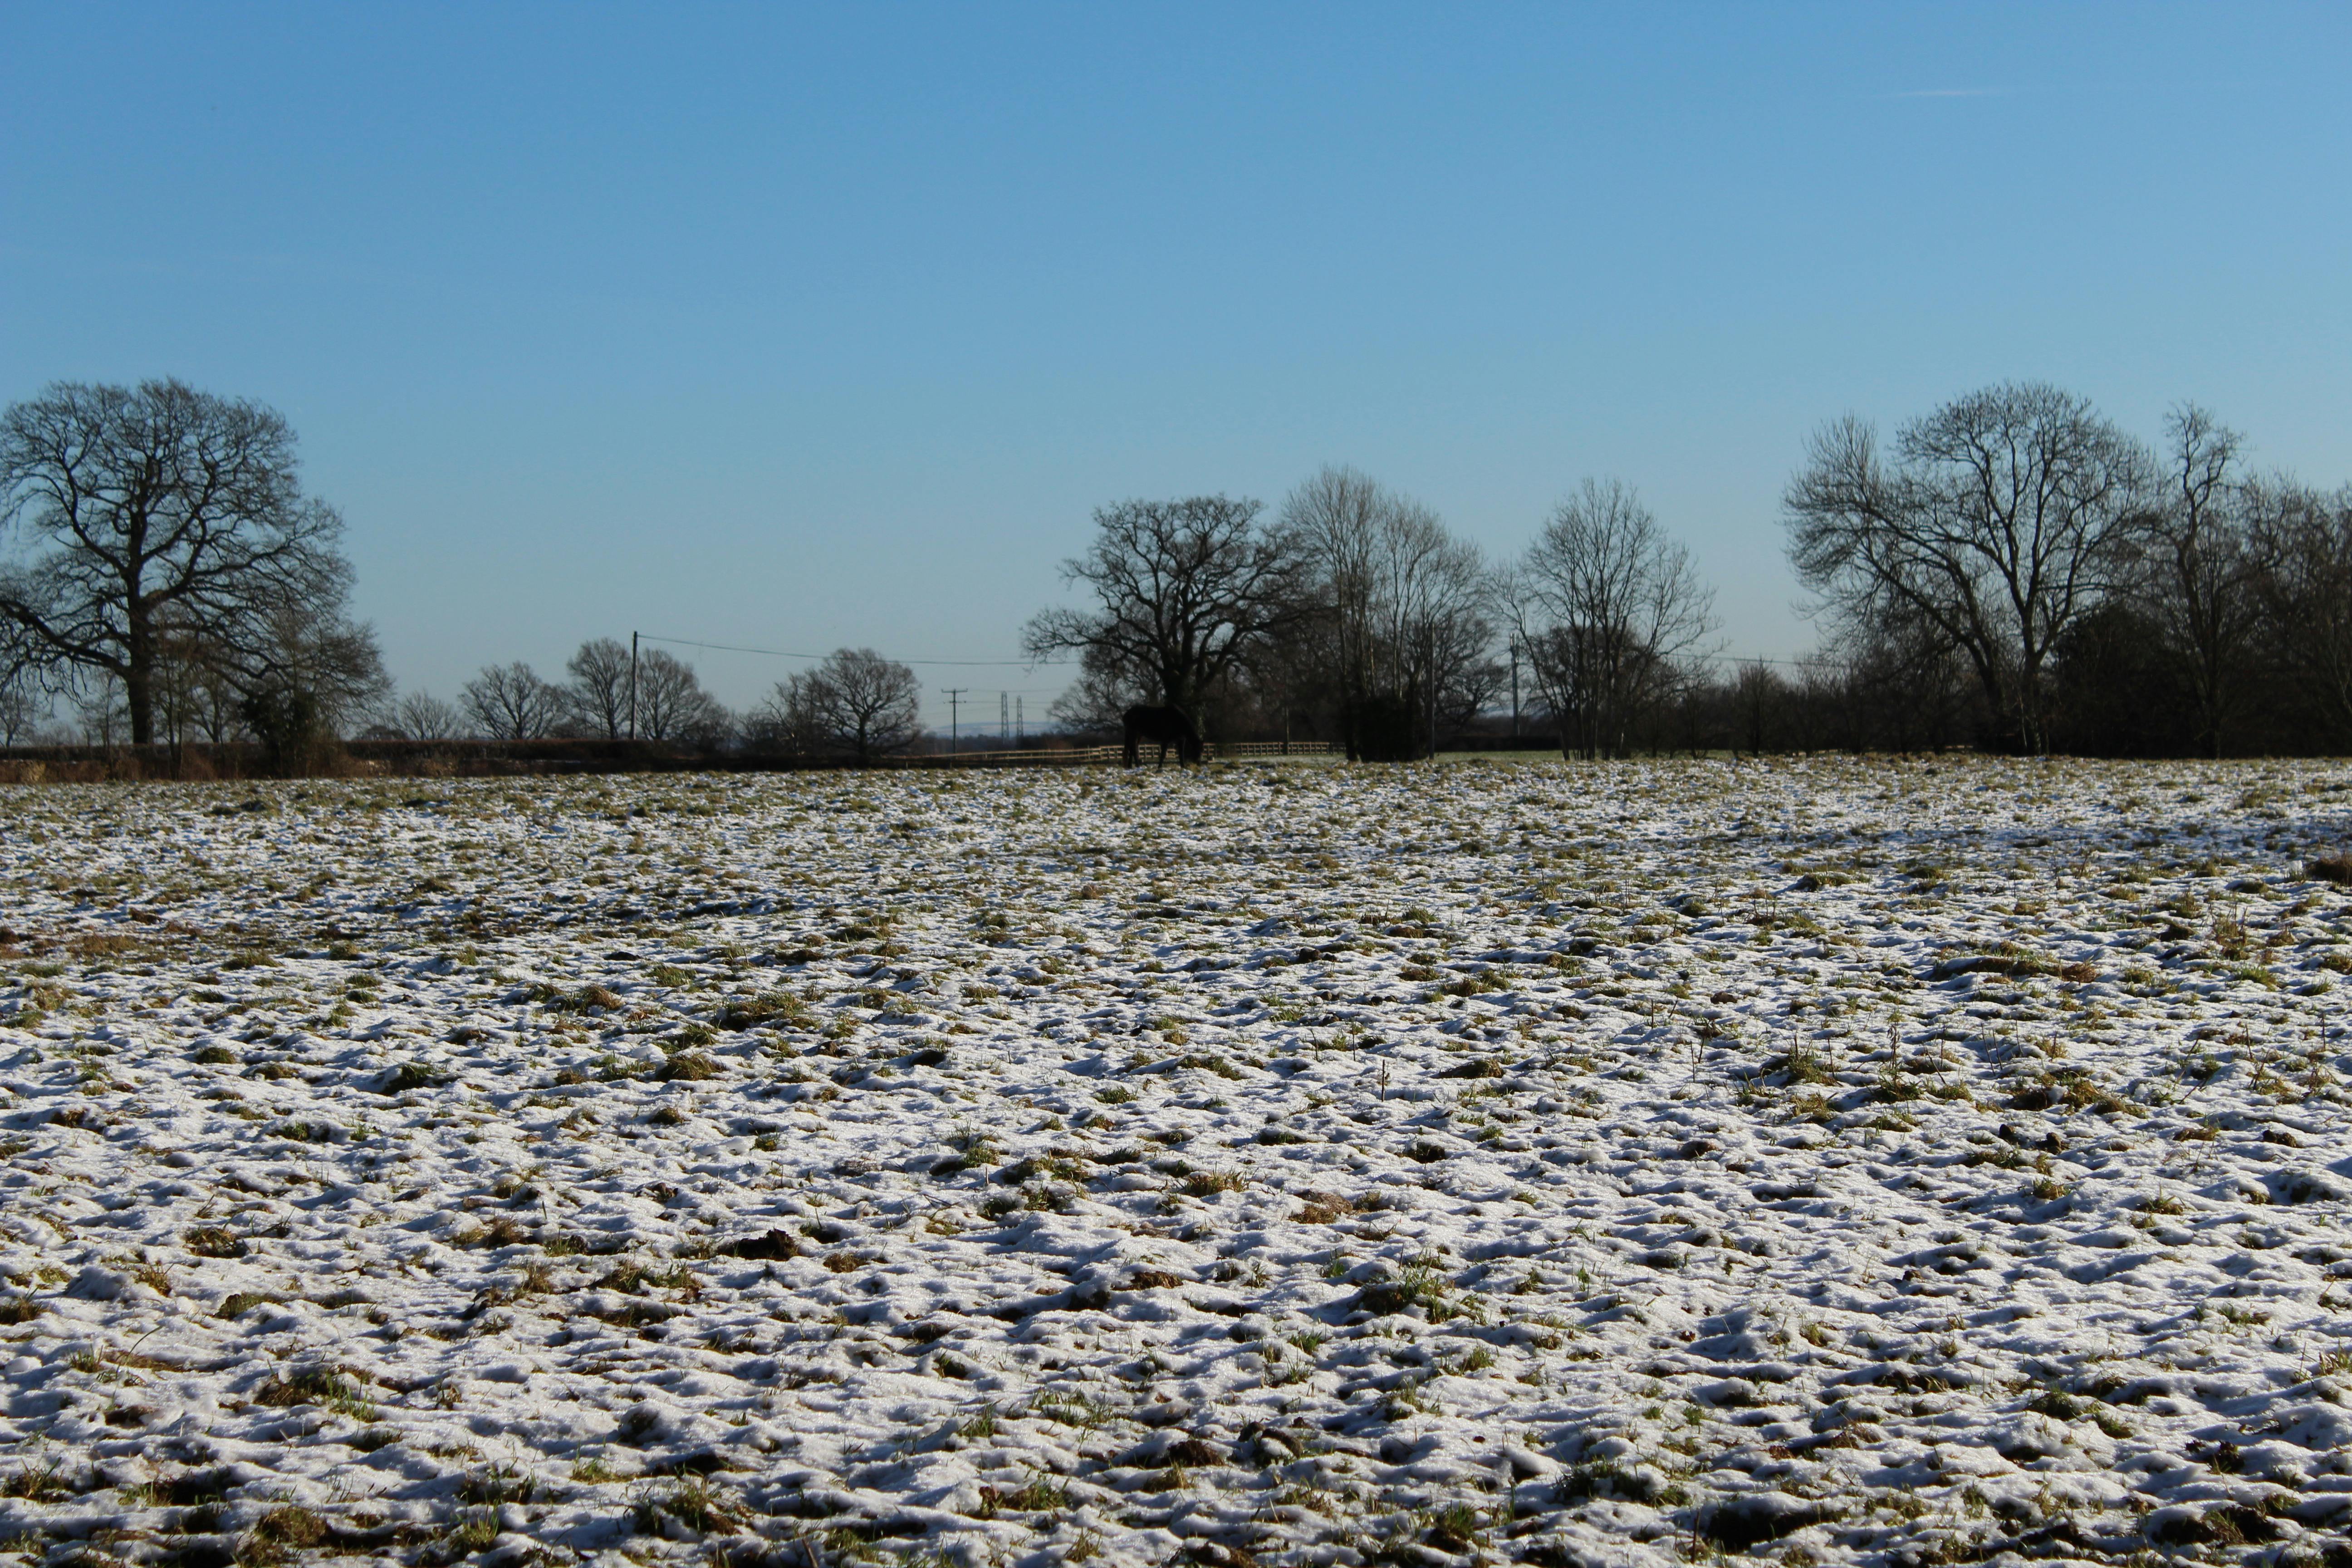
xmin=0 ymin=381 xmax=2352 ymax=771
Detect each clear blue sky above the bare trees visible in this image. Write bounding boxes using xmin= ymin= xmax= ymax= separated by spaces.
xmin=0 ymin=0 xmax=2352 ymax=722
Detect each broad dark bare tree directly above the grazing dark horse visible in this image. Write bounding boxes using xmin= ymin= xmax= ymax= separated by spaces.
xmin=1021 ymin=496 xmax=1301 ymax=712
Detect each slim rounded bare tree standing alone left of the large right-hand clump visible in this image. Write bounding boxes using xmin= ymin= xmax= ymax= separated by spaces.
xmin=1508 ymin=480 xmax=1715 ymax=760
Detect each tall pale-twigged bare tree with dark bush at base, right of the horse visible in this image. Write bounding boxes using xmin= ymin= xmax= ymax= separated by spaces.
xmin=1282 ymin=468 xmax=1500 ymax=760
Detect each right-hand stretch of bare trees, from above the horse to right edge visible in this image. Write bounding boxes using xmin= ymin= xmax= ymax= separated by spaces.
xmin=1025 ymin=383 xmax=2352 ymax=760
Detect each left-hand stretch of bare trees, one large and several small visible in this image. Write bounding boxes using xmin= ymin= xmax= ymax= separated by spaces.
xmin=0 ymin=378 xmax=945 ymax=774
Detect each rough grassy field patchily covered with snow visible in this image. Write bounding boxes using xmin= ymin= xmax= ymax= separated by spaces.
xmin=0 ymin=760 xmax=2352 ymax=1568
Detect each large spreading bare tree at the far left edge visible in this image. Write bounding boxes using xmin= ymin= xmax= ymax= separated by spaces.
xmin=0 ymin=381 xmax=362 ymax=745
